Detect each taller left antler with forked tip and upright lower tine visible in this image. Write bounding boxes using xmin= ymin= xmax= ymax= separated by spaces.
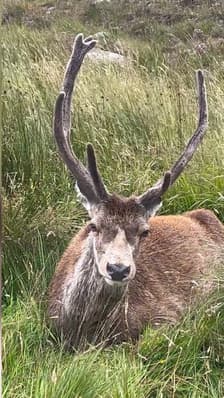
xmin=54 ymin=34 xmax=108 ymax=204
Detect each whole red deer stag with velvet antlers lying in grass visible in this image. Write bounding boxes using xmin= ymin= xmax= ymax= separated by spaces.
xmin=48 ymin=34 xmax=224 ymax=348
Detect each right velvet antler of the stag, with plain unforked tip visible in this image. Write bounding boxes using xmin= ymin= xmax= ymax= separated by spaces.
xmin=138 ymin=70 xmax=208 ymax=208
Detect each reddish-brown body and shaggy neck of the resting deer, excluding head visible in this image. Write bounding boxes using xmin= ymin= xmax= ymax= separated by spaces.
xmin=49 ymin=205 xmax=224 ymax=347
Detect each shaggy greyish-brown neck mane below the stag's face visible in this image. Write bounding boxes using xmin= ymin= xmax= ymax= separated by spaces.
xmin=62 ymin=236 xmax=127 ymax=347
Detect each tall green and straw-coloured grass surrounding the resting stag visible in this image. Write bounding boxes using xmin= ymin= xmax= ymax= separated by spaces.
xmin=1 ymin=1 xmax=224 ymax=398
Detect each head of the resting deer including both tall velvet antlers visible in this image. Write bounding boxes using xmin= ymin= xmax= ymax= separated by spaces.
xmin=54 ymin=34 xmax=208 ymax=285
